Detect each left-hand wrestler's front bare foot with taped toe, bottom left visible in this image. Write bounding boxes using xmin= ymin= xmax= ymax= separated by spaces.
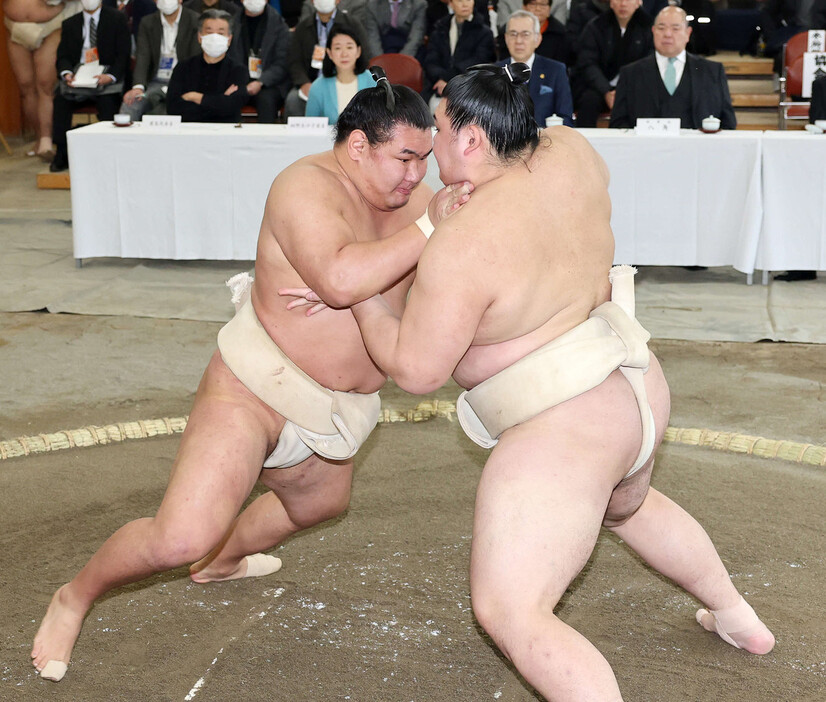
xmin=32 ymin=585 xmax=86 ymax=682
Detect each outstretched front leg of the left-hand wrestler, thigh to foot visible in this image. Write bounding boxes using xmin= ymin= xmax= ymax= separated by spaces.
xmin=32 ymin=353 xmax=350 ymax=670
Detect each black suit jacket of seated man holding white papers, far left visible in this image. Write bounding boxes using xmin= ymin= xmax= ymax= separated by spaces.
xmin=56 ymin=6 xmax=132 ymax=81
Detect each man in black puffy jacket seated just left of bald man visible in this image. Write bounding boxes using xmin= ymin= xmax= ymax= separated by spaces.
xmin=571 ymin=0 xmax=654 ymax=127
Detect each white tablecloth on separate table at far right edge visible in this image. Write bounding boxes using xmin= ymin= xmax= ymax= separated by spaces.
xmin=757 ymin=132 xmax=826 ymax=271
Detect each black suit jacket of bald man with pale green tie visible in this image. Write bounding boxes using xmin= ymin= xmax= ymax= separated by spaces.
xmin=611 ymin=53 xmax=737 ymax=129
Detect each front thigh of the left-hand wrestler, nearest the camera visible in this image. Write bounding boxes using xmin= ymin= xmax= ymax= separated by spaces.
xmin=156 ymin=352 xmax=283 ymax=533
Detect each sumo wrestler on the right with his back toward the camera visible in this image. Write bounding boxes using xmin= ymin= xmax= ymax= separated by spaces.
xmin=283 ymin=63 xmax=774 ymax=702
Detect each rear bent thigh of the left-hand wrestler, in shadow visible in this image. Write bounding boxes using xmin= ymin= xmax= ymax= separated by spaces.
xmin=260 ymin=454 xmax=353 ymax=528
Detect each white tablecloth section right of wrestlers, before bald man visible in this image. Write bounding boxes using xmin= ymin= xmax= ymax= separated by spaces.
xmin=581 ymin=129 xmax=762 ymax=273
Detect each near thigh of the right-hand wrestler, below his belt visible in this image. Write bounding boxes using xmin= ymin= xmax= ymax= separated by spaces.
xmin=471 ymin=420 xmax=613 ymax=616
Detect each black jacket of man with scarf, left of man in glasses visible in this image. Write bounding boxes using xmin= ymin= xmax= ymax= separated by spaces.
xmin=424 ymin=15 xmax=496 ymax=86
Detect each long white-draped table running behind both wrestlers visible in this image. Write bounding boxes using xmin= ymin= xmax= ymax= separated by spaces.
xmin=68 ymin=122 xmax=762 ymax=273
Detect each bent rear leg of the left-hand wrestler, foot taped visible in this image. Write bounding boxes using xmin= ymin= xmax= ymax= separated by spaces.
xmin=189 ymin=455 xmax=353 ymax=583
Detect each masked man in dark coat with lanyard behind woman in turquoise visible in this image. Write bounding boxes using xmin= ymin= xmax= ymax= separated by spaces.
xmin=284 ymin=0 xmax=372 ymax=117
